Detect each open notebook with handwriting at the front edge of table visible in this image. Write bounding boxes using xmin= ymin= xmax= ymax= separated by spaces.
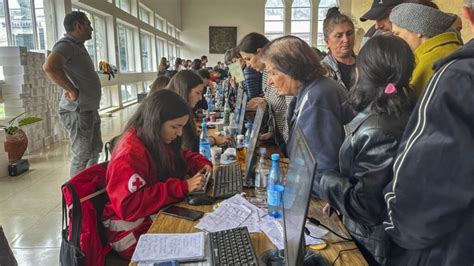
xmin=132 ymin=232 xmax=205 ymax=262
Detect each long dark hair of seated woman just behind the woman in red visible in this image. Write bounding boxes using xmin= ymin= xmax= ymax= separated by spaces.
xmin=168 ymin=70 xmax=204 ymax=151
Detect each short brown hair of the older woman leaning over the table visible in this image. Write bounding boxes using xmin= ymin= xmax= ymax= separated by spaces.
xmin=261 ymin=35 xmax=326 ymax=83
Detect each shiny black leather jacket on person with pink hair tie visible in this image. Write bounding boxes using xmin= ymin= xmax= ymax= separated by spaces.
xmin=320 ymin=108 xmax=408 ymax=265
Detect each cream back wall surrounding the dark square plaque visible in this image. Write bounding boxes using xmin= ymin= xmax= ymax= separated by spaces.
xmin=181 ymin=0 xmax=265 ymax=66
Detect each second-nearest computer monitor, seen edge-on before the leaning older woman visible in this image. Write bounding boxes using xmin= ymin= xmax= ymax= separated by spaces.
xmin=245 ymin=103 xmax=266 ymax=186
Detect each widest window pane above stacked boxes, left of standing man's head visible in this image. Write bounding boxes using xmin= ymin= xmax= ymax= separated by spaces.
xmin=8 ymin=0 xmax=35 ymax=49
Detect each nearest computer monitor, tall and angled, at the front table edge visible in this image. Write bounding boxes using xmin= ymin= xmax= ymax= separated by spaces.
xmin=283 ymin=125 xmax=316 ymax=266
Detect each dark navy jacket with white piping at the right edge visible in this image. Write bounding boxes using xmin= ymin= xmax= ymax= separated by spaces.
xmin=384 ymin=40 xmax=474 ymax=266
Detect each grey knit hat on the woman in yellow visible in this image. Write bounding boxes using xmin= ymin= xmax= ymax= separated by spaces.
xmin=390 ymin=3 xmax=455 ymax=38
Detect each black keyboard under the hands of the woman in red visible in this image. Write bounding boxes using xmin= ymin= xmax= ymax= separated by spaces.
xmin=214 ymin=164 xmax=243 ymax=199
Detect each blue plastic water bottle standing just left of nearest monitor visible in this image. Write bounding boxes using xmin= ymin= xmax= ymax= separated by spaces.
xmin=267 ymin=153 xmax=283 ymax=218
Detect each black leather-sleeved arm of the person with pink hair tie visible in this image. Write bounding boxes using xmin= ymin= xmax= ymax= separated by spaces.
xmin=320 ymin=129 xmax=398 ymax=225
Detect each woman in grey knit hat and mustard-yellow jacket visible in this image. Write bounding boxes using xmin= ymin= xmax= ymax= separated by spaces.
xmin=390 ymin=3 xmax=461 ymax=98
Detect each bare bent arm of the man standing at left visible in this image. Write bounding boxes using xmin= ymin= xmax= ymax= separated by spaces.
xmin=43 ymin=51 xmax=79 ymax=101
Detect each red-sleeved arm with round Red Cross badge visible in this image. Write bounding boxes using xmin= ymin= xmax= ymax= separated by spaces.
xmin=106 ymin=152 xmax=188 ymax=221
